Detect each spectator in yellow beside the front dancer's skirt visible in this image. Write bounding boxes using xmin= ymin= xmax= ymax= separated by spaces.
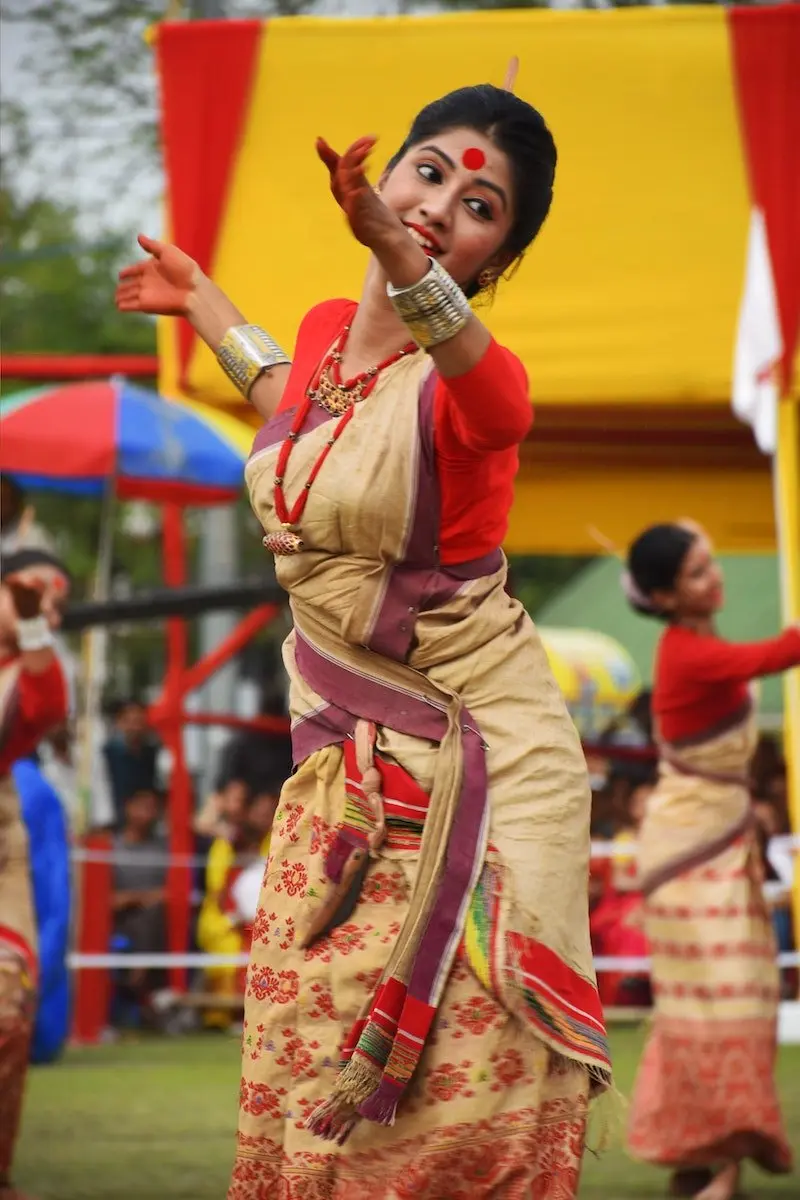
xmin=197 ymin=775 xmax=283 ymax=1028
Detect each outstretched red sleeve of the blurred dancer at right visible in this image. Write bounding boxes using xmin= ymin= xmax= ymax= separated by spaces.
xmin=669 ymin=628 xmax=800 ymax=684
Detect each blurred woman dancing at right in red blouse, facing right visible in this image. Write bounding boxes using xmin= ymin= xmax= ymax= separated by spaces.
xmin=624 ymin=522 xmax=800 ymax=1200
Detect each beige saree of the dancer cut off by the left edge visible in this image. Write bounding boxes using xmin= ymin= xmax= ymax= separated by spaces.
xmin=0 ymin=664 xmax=36 ymax=1186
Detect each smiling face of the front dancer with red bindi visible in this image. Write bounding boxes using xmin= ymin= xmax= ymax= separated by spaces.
xmin=380 ymin=128 xmax=513 ymax=287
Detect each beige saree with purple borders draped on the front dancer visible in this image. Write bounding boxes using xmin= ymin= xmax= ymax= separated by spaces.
xmin=229 ymin=354 xmax=609 ymax=1200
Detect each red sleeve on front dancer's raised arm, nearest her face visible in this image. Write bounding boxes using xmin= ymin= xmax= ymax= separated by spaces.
xmin=435 ymin=338 xmax=534 ymax=454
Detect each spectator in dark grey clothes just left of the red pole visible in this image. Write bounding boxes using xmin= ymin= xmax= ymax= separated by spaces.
xmin=112 ymin=787 xmax=169 ymax=1022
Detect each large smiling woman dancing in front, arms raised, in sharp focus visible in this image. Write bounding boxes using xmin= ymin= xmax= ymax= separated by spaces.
xmin=118 ymin=84 xmax=609 ymax=1200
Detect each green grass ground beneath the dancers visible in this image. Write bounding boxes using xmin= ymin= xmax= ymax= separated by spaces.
xmin=16 ymin=1028 xmax=800 ymax=1200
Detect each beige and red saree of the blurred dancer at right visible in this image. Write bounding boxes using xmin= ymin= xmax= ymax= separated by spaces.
xmin=628 ymin=706 xmax=792 ymax=1172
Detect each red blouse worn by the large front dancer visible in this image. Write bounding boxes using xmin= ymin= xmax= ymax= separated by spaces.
xmin=278 ymin=300 xmax=533 ymax=564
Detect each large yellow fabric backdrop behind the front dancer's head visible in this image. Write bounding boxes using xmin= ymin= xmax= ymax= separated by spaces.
xmin=162 ymin=6 xmax=748 ymax=404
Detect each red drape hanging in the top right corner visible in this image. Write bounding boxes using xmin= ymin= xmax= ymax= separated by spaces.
xmin=728 ymin=5 xmax=800 ymax=392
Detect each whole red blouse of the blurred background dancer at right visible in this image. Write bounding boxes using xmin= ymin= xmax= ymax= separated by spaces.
xmin=652 ymin=625 xmax=800 ymax=742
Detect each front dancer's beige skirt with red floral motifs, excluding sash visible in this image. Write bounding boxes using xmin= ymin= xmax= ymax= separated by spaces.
xmin=229 ymin=744 xmax=588 ymax=1200
